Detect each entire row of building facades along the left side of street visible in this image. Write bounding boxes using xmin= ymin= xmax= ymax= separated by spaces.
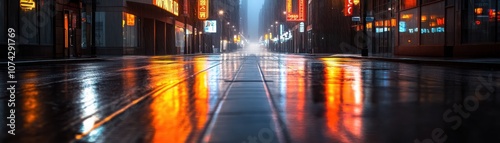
xmin=0 ymin=0 xmax=239 ymax=59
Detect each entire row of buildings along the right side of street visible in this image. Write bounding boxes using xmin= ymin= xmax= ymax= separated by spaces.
xmin=259 ymin=0 xmax=500 ymax=57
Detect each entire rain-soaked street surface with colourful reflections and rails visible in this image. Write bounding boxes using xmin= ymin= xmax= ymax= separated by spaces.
xmin=0 ymin=53 xmax=500 ymax=143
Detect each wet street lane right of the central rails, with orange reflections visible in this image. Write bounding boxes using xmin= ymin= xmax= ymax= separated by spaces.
xmin=262 ymin=55 xmax=500 ymax=143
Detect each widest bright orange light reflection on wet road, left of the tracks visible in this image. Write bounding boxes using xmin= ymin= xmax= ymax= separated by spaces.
xmin=149 ymin=61 xmax=191 ymax=143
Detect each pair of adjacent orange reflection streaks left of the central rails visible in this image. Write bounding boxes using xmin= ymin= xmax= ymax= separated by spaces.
xmin=150 ymin=61 xmax=209 ymax=143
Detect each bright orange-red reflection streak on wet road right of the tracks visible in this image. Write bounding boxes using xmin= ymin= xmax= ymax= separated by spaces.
xmin=322 ymin=59 xmax=363 ymax=142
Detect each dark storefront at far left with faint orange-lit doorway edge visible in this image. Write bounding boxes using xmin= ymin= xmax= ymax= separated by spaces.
xmin=0 ymin=0 xmax=86 ymax=59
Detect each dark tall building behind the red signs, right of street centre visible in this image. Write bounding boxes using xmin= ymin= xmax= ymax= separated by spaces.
xmin=306 ymin=0 xmax=358 ymax=53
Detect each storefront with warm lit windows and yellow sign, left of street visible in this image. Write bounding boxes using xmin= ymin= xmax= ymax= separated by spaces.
xmin=96 ymin=0 xmax=192 ymax=55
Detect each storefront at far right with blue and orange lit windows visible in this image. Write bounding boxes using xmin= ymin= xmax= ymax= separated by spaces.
xmin=395 ymin=0 xmax=500 ymax=57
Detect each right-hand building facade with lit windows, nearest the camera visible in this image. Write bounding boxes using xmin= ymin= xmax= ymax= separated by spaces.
xmin=350 ymin=0 xmax=500 ymax=57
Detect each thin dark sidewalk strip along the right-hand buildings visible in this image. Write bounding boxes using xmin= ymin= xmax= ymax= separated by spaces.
xmin=298 ymin=54 xmax=500 ymax=67
